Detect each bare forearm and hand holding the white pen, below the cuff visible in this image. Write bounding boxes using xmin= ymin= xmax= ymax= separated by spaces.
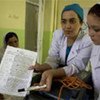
xmin=40 ymin=68 xmax=66 ymax=91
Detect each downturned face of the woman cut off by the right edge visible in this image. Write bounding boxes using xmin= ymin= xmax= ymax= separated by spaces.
xmin=87 ymin=14 xmax=100 ymax=45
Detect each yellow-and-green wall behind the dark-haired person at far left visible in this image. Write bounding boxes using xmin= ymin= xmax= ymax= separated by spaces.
xmin=0 ymin=0 xmax=25 ymax=48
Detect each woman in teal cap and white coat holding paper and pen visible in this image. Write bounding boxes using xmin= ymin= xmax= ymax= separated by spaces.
xmin=31 ymin=4 xmax=92 ymax=95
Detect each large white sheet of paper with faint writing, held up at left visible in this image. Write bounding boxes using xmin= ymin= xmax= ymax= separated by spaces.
xmin=0 ymin=46 xmax=37 ymax=96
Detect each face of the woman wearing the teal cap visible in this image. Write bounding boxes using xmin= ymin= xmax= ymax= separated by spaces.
xmin=61 ymin=10 xmax=82 ymax=38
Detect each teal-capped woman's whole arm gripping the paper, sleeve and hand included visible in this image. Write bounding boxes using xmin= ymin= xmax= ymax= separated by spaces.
xmin=30 ymin=30 xmax=61 ymax=72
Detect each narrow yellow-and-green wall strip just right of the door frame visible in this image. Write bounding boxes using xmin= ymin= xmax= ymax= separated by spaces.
xmin=42 ymin=0 xmax=55 ymax=62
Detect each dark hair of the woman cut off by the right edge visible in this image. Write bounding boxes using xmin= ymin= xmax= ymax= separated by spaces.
xmin=88 ymin=4 xmax=100 ymax=17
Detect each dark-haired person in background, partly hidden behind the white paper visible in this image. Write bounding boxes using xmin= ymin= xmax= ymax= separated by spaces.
xmin=0 ymin=32 xmax=19 ymax=62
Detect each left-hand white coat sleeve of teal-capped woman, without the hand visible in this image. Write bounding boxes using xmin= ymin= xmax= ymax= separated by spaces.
xmin=45 ymin=30 xmax=63 ymax=68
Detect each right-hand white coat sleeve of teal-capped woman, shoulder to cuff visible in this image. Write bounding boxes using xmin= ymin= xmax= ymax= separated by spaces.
xmin=63 ymin=35 xmax=93 ymax=76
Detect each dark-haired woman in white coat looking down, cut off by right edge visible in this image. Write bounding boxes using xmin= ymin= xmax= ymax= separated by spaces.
xmin=87 ymin=4 xmax=100 ymax=100
